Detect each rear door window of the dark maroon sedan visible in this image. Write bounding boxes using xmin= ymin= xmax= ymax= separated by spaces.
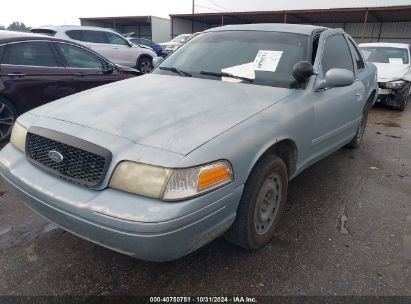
xmin=3 ymin=41 xmax=59 ymax=67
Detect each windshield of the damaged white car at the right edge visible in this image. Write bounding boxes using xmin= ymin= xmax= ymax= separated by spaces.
xmin=360 ymin=46 xmax=409 ymax=64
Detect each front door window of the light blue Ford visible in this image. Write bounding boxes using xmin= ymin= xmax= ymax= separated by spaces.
xmin=321 ymin=35 xmax=354 ymax=75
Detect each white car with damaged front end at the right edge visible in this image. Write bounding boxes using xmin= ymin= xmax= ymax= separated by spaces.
xmin=359 ymin=42 xmax=411 ymax=111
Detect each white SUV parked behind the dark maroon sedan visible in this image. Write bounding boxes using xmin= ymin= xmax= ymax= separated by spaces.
xmin=31 ymin=26 xmax=157 ymax=74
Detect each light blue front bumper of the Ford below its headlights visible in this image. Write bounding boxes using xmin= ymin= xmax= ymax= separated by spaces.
xmin=0 ymin=144 xmax=243 ymax=262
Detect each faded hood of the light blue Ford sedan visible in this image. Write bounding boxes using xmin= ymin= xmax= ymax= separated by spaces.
xmin=30 ymin=74 xmax=293 ymax=155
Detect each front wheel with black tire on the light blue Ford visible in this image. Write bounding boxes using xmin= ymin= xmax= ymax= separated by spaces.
xmin=225 ymin=155 xmax=288 ymax=249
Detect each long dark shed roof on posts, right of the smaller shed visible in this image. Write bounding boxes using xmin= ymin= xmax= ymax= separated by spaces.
xmin=170 ymin=5 xmax=411 ymax=24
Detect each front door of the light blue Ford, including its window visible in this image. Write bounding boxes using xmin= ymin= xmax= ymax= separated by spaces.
xmin=312 ymin=30 xmax=365 ymax=155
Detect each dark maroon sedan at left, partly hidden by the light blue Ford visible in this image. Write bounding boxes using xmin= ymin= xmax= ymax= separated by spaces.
xmin=0 ymin=31 xmax=141 ymax=142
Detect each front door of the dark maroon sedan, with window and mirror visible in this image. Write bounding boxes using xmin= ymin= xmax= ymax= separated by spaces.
xmin=53 ymin=42 xmax=120 ymax=92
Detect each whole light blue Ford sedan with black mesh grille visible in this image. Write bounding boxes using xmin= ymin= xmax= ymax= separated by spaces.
xmin=0 ymin=24 xmax=377 ymax=261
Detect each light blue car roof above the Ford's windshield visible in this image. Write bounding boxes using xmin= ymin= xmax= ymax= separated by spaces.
xmin=206 ymin=23 xmax=326 ymax=35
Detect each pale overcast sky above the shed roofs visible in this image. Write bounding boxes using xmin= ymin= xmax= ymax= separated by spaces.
xmin=0 ymin=0 xmax=411 ymax=27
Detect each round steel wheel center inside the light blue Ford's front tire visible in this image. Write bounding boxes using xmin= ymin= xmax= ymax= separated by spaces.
xmin=254 ymin=173 xmax=283 ymax=235
